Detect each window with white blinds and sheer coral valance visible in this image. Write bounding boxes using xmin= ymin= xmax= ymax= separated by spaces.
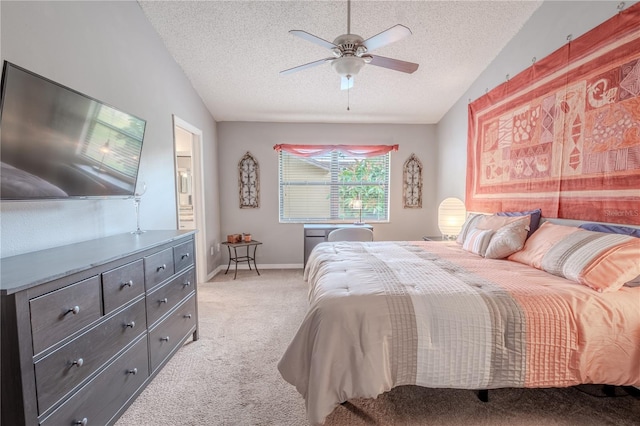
xmin=275 ymin=145 xmax=397 ymax=223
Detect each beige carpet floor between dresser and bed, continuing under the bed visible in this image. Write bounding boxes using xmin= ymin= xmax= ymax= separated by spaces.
xmin=116 ymin=270 xmax=640 ymax=426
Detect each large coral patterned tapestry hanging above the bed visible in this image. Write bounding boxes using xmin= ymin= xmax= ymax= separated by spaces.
xmin=466 ymin=3 xmax=640 ymax=225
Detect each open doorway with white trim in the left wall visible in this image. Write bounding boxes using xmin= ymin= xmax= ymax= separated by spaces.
xmin=173 ymin=115 xmax=208 ymax=282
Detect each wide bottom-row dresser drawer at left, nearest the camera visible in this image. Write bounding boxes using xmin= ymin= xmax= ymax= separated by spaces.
xmin=40 ymin=335 xmax=149 ymax=426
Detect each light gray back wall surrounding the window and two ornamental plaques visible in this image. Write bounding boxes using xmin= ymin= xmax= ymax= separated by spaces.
xmin=218 ymin=122 xmax=439 ymax=267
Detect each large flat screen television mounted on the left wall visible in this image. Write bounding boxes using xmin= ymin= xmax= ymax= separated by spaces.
xmin=0 ymin=61 xmax=146 ymax=200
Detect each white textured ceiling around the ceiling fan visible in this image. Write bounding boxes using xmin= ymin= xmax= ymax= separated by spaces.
xmin=139 ymin=0 xmax=541 ymax=123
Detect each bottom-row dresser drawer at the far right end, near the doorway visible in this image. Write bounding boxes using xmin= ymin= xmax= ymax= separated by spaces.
xmin=149 ymin=295 xmax=196 ymax=372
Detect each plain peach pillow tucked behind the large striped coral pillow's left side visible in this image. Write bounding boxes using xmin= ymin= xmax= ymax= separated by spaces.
xmin=509 ymin=222 xmax=587 ymax=269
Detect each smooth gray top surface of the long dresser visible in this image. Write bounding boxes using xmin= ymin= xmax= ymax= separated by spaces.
xmin=0 ymin=230 xmax=195 ymax=295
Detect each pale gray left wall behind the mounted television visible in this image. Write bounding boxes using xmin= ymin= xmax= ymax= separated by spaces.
xmin=0 ymin=1 xmax=220 ymax=271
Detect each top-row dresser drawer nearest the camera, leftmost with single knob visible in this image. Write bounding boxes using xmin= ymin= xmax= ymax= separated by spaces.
xmin=29 ymin=276 xmax=102 ymax=354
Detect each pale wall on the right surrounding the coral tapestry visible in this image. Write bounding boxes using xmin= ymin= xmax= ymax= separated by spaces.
xmin=436 ymin=0 xmax=636 ymax=200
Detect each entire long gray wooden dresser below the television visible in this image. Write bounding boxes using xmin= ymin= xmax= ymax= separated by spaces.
xmin=0 ymin=231 xmax=198 ymax=426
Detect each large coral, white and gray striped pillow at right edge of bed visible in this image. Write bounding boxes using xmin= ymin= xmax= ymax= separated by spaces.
xmin=541 ymin=231 xmax=640 ymax=291
